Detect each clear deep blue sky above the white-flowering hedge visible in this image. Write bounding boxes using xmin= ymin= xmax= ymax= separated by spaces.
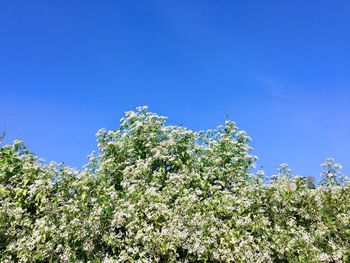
xmin=0 ymin=0 xmax=350 ymax=182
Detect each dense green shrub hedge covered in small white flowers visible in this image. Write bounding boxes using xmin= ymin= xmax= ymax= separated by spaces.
xmin=0 ymin=107 xmax=350 ymax=262
